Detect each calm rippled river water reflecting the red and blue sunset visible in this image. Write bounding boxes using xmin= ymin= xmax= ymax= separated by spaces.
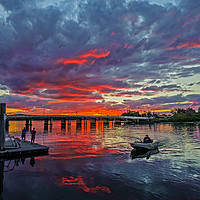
xmin=0 ymin=122 xmax=200 ymax=200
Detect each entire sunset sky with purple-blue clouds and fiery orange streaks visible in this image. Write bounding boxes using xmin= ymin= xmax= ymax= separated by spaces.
xmin=0 ymin=0 xmax=200 ymax=115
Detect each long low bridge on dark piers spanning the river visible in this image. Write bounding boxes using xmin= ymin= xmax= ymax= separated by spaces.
xmin=6 ymin=115 xmax=153 ymax=130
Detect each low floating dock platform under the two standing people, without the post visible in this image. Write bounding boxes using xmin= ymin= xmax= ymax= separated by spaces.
xmin=0 ymin=141 xmax=49 ymax=160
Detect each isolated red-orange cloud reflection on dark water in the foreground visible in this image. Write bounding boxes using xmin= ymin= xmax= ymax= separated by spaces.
xmin=59 ymin=176 xmax=111 ymax=193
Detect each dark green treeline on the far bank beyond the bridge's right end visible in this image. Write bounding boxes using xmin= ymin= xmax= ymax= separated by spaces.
xmin=122 ymin=107 xmax=200 ymax=122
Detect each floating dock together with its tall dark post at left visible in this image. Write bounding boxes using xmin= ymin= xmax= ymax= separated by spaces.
xmin=0 ymin=103 xmax=49 ymax=160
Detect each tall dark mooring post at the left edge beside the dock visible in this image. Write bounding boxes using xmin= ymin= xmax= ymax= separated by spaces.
xmin=0 ymin=103 xmax=6 ymax=151
